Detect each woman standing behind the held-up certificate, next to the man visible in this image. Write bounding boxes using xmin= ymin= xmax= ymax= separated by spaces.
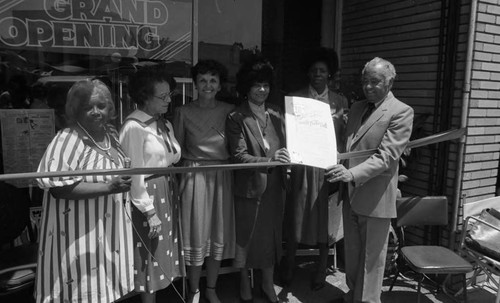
xmin=282 ymin=48 xmax=348 ymax=290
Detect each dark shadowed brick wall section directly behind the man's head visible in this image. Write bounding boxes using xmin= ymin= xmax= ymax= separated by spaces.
xmin=340 ymin=0 xmax=440 ymax=195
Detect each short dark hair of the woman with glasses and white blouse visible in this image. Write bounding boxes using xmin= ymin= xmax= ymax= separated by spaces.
xmin=128 ymin=64 xmax=177 ymax=106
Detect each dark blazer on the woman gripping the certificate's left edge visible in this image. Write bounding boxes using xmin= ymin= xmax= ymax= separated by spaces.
xmin=226 ymin=101 xmax=286 ymax=198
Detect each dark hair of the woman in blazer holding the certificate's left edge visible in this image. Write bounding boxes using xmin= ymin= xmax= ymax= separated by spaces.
xmin=236 ymin=56 xmax=274 ymax=97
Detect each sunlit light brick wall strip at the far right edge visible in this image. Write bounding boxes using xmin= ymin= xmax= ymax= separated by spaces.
xmin=462 ymin=0 xmax=500 ymax=203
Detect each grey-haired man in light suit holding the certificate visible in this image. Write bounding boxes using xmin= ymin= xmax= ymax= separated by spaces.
xmin=325 ymin=57 xmax=413 ymax=303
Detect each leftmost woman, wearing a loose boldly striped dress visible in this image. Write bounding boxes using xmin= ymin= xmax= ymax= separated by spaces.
xmin=35 ymin=80 xmax=134 ymax=303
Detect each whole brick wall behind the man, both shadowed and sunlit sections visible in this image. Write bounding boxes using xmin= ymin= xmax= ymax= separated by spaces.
xmin=341 ymin=0 xmax=500 ymax=207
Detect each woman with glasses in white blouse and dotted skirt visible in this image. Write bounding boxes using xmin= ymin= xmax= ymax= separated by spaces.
xmin=120 ymin=66 xmax=185 ymax=303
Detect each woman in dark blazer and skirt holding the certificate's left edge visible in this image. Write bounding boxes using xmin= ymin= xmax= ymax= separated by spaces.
xmin=226 ymin=59 xmax=290 ymax=302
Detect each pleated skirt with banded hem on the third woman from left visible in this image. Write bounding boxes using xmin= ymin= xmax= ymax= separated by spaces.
xmin=179 ymin=160 xmax=236 ymax=266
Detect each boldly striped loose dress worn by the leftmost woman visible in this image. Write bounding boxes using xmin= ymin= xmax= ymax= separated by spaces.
xmin=35 ymin=128 xmax=134 ymax=302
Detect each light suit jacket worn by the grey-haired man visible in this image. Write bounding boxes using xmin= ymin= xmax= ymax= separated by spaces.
xmin=344 ymin=92 xmax=413 ymax=218
